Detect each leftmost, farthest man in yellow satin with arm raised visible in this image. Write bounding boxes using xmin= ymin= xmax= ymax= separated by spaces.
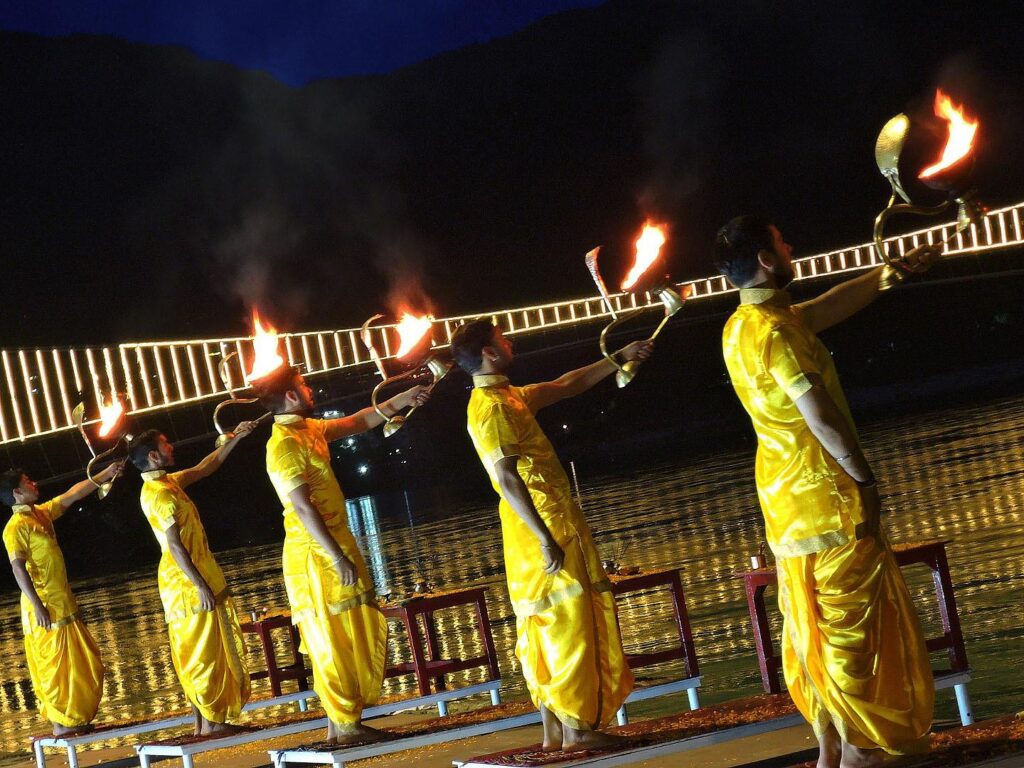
xmin=0 ymin=463 xmax=122 ymax=736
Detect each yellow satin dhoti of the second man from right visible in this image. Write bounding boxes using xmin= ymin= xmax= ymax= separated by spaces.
xmin=512 ymin=524 xmax=633 ymax=730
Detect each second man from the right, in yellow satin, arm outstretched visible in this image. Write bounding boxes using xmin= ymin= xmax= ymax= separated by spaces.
xmin=452 ymin=319 xmax=651 ymax=750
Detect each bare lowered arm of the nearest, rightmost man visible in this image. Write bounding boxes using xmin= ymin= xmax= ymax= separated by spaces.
xmin=796 ymin=375 xmax=882 ymax=534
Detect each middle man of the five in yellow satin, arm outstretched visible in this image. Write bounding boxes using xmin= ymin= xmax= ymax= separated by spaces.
xmin=253 ymin=367 xmax=429 ymax=743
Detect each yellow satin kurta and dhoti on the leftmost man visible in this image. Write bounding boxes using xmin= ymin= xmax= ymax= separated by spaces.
xmin=3 ymin=498 xmax=103 ymax=727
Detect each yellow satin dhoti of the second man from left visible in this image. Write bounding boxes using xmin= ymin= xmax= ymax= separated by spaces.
xmin=167 ymin=597 xmax=250 ymax=723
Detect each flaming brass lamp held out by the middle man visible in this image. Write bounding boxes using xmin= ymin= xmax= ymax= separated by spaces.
xmin=359 ymin=312 xmax=454 ymax=437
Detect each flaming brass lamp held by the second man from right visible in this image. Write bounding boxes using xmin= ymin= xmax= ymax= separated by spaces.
xmin=586 ymin=222 xmax=692 ymax=387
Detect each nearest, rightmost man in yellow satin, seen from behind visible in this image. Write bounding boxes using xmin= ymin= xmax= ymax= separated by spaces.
xmin=715 ymin=216 xmax=938 ymax=768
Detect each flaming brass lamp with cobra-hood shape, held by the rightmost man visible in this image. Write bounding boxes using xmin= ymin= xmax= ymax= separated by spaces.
xmin=874 ymin=90 xmax=985 ymax=290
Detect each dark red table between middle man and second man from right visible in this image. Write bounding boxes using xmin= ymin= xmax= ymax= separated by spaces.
xmin=381 ymin=587 xmax=501 ymax=717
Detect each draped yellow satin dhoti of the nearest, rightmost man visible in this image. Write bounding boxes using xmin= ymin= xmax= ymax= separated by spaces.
xmin=778 ymin=538 xmax=935 ymax=754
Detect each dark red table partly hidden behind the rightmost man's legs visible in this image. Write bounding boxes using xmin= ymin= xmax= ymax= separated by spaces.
xmin=734 ymin=539 xmax=974 ymax=725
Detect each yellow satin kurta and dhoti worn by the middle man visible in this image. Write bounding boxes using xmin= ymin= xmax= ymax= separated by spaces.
xmin=266 ymin=415 xmax=387 ymax=726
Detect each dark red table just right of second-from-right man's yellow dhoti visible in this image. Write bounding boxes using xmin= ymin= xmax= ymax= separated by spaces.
xmin=608 ymin=568 xmax=700 ymax=725
